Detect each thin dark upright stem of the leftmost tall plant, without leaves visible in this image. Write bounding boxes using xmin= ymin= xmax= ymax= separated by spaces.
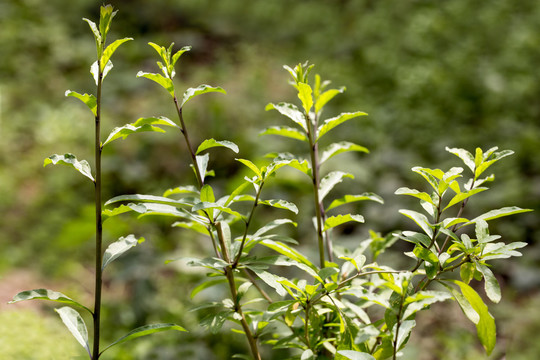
xmin=92 ymin=61 xmax=103 ymax=360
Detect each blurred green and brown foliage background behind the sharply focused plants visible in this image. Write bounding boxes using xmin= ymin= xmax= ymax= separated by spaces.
xmin=0 ymin=0 xmax=540 ymax=360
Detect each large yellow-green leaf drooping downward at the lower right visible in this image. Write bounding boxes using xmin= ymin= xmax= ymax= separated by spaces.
xmin=452 ymin=280 xmax=497 ymax=355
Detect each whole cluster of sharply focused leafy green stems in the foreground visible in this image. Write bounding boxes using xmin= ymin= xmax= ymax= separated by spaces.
xmin=14 ymin=6 xmax=529 ymax=360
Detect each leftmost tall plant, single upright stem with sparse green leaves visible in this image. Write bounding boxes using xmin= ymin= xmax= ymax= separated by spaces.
xmin=11 ymin=5 xmax=184 ymax=360
